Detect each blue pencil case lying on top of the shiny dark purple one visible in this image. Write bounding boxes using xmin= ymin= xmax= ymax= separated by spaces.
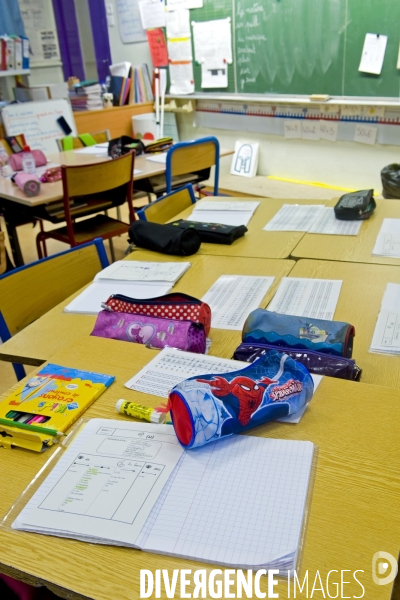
xmin=242 ymin=308 xmax=355 ymax=358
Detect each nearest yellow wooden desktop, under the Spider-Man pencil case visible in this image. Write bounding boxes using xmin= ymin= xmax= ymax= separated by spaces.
xmin=0 ymin=337 xmax=400 ymax=600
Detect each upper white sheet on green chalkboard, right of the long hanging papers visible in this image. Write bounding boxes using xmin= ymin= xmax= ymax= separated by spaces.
xmin=192 ymin=17 xmax=232 ymax=64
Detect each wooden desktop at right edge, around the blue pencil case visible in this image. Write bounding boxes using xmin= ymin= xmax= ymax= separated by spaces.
xmin=290 ymin=259 xmax=400 ymax=388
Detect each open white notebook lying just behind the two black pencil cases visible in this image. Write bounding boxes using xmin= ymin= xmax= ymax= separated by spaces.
xmin=188 ymin=201 xmax=260 ymax=225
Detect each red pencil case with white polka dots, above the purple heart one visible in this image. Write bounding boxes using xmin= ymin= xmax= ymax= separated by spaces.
xmin=101 ymin=292 xmax=211 ymax=335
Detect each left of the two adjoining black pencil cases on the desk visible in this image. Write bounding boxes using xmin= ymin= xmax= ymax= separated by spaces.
xmin=129 ymin=221 xmax=201 ymax=256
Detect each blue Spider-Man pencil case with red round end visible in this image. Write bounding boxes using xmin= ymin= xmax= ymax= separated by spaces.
xmin=166 ymin=351 xmax=314 ymax=448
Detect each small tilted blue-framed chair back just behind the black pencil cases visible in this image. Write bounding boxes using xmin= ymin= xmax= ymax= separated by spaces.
xmin=136 ymin=183 xmax=196 ymax=223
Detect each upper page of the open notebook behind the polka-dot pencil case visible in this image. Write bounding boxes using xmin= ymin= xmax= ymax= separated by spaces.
xmin=94 ymin=260 xmax=190 ymax=283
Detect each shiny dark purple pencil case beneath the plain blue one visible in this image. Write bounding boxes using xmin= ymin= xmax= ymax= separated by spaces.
xmin=233 ymin=342 xmax=362 ymax=381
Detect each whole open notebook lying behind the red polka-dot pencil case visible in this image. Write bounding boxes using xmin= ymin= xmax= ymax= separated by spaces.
xmin=64 ymin=260 xmax=190 ymax=314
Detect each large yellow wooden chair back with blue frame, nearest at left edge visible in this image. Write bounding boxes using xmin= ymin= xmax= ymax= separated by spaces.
xmin=0 ymin=238 xmax=109 ymax=380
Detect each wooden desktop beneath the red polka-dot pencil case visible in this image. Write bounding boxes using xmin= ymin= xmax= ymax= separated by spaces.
xmin=0 ymin=250 xmax=294 ymax=365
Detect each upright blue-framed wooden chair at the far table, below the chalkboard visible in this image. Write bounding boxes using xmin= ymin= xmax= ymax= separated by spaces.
xmin=165 ymin=136 xmax=219 ymax=196
